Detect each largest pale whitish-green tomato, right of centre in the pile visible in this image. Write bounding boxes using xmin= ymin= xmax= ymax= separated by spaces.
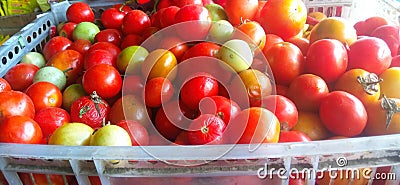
xmin=218 ymin=39 xmax=253 ymax=73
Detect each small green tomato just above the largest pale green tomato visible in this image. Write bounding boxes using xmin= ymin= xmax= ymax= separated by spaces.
xmin=209 ymin=20 xmax=235 ymax=44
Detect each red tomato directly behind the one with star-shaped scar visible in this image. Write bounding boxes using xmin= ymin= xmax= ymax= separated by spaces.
xmin=199 ymin=96 xmax=241 ymax=124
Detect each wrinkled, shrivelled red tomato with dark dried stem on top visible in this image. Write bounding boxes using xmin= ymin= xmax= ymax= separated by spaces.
xmin=70 ymin=93 xmax=110 ymax=129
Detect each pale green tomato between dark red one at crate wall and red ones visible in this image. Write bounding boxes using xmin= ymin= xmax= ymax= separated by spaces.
xmin=33 ymin=66 xmax=67 ymax=90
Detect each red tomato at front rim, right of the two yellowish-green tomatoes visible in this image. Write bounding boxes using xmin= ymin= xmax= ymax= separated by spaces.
xmin=116 ymin=120 xmax=150 ymax=146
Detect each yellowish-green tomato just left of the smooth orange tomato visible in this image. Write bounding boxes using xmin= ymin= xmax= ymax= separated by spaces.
xmin=117 ymin=46 xmax=149 ymax=74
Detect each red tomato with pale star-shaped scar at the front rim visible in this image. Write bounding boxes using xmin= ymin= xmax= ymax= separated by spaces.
xmin=187 ymin=114 xmax=226 ymax=145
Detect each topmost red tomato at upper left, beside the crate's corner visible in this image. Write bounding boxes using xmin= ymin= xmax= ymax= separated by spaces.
xmin=66 ymin=2 xmax=94 ymax=24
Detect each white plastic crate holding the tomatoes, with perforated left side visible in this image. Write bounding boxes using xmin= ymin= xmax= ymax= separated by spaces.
xmin=0 ymin=0 xmax=400 ymax=185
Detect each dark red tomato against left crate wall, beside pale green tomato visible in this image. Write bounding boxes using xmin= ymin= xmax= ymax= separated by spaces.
xmin=4 ymin=63 xmax=39 ymax=91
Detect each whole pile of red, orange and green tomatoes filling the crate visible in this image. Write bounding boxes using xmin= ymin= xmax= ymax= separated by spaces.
xmin=0 ymin=0 xmax=400 ymax=155
